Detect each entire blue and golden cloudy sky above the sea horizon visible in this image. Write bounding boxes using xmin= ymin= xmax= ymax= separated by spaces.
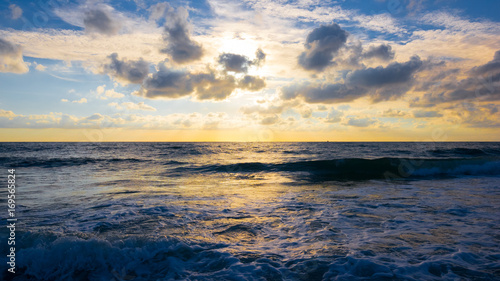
xmin=0 ymin=0 xmax=500 ymax=142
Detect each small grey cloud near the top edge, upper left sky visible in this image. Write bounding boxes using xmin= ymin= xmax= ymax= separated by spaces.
xmin=83 ymin=9 xmax=120 ymax=35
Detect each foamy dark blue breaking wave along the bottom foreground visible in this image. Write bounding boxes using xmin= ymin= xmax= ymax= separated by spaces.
xmin=0 ymin=232 xmax=498 ymax=281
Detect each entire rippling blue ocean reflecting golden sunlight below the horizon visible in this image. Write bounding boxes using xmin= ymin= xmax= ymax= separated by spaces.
xmin=0 ymin=142 xmax=500 ymax=280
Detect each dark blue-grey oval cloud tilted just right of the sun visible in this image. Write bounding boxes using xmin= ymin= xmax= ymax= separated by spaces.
xmin=298 ymin=23 xmax=348 ymax=72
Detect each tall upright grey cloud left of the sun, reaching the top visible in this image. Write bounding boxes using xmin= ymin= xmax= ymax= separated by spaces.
xmin=160 ymin=5 xmax=203 ymax=64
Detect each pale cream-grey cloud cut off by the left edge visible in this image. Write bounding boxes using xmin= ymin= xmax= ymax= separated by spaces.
xmin=0 ymin=38 xmax=29 ymax=73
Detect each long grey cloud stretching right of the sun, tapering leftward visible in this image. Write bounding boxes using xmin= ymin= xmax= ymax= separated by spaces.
xmin=282 ymin=56 xmax=424 ymax=103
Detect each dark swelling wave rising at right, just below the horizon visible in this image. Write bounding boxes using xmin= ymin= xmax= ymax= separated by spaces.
xmin=175 ymin=158 xmax=500 ymax=180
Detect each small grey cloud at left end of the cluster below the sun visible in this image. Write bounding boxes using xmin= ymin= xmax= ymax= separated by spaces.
xmin=102 ymin=53 xmax=149 ymax=84
